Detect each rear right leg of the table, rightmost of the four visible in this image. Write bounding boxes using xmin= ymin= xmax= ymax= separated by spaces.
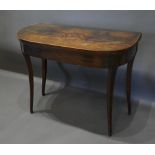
xmin=126 ymin=59 xmax=134 ymax=115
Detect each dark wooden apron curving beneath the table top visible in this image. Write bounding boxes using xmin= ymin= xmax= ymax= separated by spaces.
xmin=21 ymin=41 xmax=137 ymax=68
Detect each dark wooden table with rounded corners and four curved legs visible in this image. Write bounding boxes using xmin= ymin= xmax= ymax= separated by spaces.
xmin=17 ymin=23 xmax=142 ymax=136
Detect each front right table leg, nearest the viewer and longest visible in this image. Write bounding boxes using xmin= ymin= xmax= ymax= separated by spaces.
xmin=107 ymin=68 xmax=117 ymax=136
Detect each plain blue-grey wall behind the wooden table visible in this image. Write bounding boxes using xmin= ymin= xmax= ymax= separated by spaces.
xmin=0 ymin=11 xmax=155 ymax=102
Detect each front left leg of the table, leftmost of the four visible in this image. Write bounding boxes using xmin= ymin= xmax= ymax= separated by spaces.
xmin=23 ymin=54 xmax=34 ymax=113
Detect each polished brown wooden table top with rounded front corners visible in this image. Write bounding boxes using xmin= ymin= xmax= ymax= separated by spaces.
xmin=17 ymin=23 xmax=142 ymax=52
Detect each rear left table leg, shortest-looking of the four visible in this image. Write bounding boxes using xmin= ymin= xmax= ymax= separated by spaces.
xmin=42 ymin=59 xmax=47 ymax=96
